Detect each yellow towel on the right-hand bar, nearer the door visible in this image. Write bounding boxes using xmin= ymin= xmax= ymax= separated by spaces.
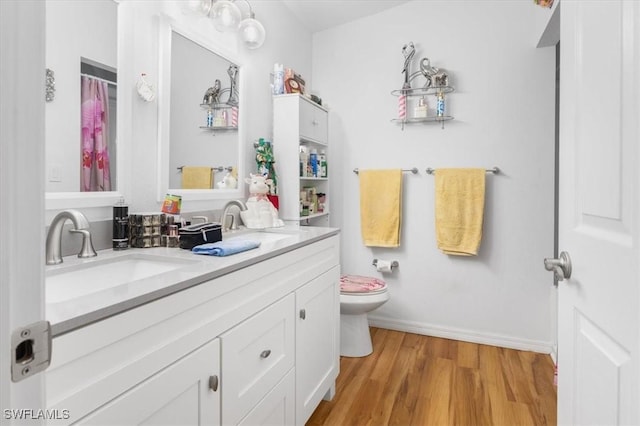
xmin=435 ymin=169 xmax=486 ymax=256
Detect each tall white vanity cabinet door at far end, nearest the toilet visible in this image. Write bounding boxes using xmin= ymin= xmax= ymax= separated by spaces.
xmin=296 ymin=266 xmax=340 ymax=425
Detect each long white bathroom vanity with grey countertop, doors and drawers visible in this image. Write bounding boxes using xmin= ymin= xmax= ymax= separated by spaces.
xmin=46 ymin=227 xmax=340 ymax=425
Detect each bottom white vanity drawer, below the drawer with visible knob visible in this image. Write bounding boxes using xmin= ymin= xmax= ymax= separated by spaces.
xmin=238 ymin=368 xmax=296 ymax=426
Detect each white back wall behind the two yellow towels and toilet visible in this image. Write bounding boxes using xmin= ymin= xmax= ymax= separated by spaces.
xmin=313 ymin=0 xmax=554 ymax=351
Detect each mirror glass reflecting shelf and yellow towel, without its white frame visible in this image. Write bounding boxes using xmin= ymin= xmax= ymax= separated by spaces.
xmin=169 ymin=31 xmax=240 ymax=189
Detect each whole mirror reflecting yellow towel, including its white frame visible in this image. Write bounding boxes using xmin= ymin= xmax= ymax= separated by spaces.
xmin=158 ymin=17 xmax=245 ymax=200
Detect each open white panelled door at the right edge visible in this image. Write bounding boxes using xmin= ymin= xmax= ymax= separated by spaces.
xmin=558 ymin=0 xmax=640 ymax=425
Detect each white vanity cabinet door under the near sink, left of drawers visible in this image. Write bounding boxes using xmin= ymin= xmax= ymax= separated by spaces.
xmin=78 ymin=339 xmax=220 ymax=425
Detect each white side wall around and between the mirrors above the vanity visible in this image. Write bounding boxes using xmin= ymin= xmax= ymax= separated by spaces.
xmin=120 ymin=1 xmax=311 ymax=215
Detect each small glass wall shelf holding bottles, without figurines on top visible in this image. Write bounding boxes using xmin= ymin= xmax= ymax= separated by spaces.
xmin=391 ymin=86 xmax=454 ymax=130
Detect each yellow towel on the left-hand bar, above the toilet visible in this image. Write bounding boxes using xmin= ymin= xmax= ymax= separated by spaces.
xmin=359 ymin=169 xmax=402 ymax=247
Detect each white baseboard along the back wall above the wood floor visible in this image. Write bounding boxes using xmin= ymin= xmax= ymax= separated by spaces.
xmin=368 ymin=315 xmax=555 ymax=354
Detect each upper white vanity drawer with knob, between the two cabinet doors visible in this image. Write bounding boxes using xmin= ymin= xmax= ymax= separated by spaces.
xmin=220 ymin=294 xmax=295 ymax=424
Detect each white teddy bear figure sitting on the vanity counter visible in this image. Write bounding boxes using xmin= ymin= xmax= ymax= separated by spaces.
xmin=240 ymin=173 xmax=284 ymax=229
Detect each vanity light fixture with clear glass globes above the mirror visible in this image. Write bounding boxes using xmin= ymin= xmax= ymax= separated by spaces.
xmin=186 ymin=0 xmax=266 ymax=49
